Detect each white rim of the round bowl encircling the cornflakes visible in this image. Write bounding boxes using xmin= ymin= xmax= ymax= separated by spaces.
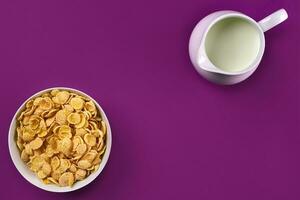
xmin=8 ymin=87 xmax=112 ymax=193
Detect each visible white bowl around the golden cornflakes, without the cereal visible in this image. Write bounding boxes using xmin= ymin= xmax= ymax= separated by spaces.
xmin=8 ymin=87 xmax=112 ymax=192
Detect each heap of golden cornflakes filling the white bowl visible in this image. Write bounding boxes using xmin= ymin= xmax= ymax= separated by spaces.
xmin=16 ymin=89 xmax=106 ymax=187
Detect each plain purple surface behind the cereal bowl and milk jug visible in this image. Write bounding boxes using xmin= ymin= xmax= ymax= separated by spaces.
xmin=0 ymin=0 xmax=300 ymax=200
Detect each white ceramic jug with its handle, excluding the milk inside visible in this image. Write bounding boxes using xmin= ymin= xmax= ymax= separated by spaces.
xmin=189 ymin=9 xmax=288 ymax=85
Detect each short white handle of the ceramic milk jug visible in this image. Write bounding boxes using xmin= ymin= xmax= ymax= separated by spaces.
xmin=258 ymin=8 xmax=288 ymax=32
